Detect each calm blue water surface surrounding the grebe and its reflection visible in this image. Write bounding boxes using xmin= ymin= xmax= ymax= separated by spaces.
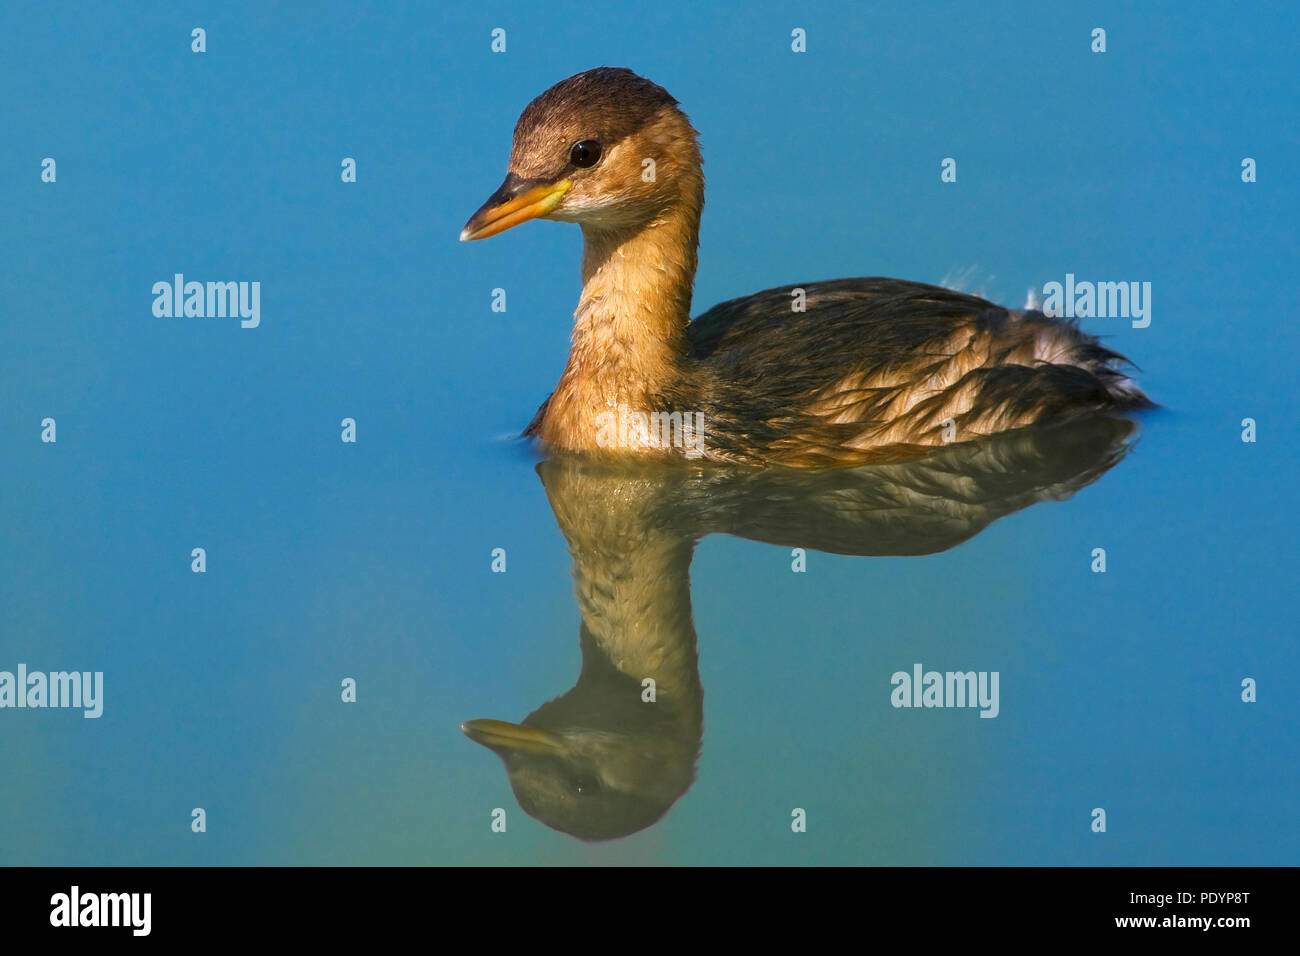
xmin=0 ymin=1 xmax=1300 ymax=865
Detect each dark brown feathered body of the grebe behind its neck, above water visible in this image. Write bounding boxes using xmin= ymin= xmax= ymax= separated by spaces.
xmin=667 ymin=278 xmax=1151 ymax=466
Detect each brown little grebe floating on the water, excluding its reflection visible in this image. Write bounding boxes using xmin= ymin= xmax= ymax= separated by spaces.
xmin=460 ymin=68 xmax=1151 ymax=467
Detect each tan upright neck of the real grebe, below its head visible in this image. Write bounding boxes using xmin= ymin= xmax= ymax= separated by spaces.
xmin=538 ymin=202 xmax=699 ymax=450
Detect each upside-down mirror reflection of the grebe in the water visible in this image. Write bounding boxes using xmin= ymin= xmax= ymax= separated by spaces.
xmin=463 ymin=415 xmax=1135 ymax=840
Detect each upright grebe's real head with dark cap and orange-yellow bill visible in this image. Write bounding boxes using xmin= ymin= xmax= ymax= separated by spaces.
xmin=460 ymin=66 xmax=703 ymax=241
